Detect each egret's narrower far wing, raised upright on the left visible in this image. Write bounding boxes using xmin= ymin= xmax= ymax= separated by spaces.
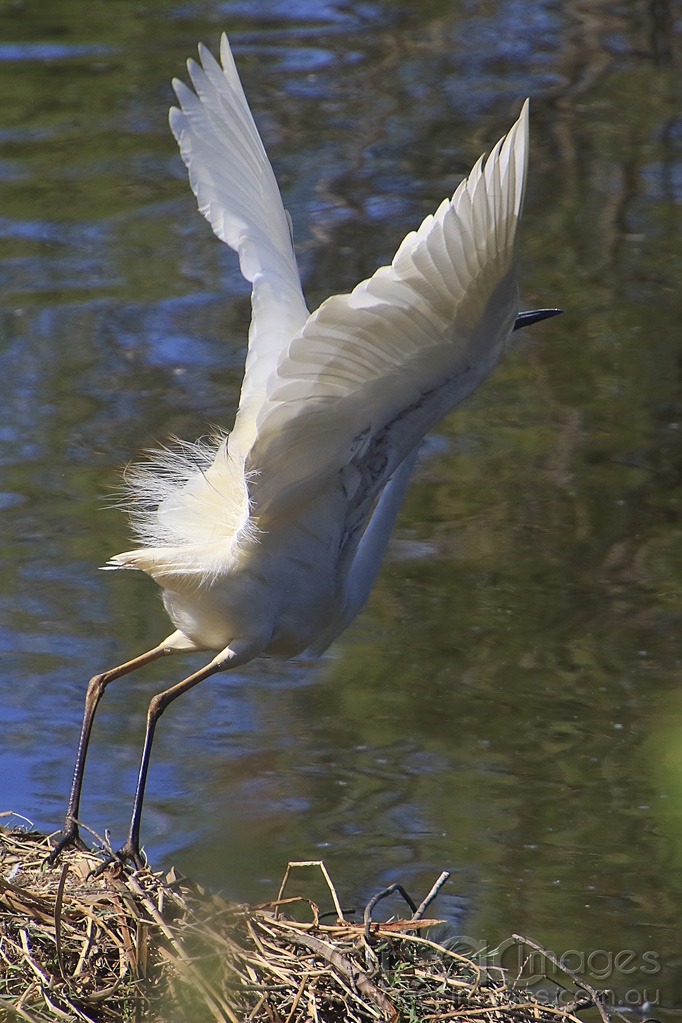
xmin=170 ymin=34 xmax=308 ymax=456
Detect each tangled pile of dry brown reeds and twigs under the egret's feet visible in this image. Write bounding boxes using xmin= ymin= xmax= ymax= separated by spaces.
xmin=0 ymin=828 xmax=608 ymax=1023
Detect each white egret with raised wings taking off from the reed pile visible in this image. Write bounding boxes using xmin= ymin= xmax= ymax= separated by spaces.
xmin=50 ymin=36 xmax=556 ymax=864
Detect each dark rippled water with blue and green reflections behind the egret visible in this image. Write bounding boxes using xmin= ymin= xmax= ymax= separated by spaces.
xmin=0 ymin=0 xmax=682 ymax=1016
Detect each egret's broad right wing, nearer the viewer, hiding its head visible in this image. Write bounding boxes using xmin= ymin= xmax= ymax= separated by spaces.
xmin=246 ymin=101 xmax=529 ymax=524
